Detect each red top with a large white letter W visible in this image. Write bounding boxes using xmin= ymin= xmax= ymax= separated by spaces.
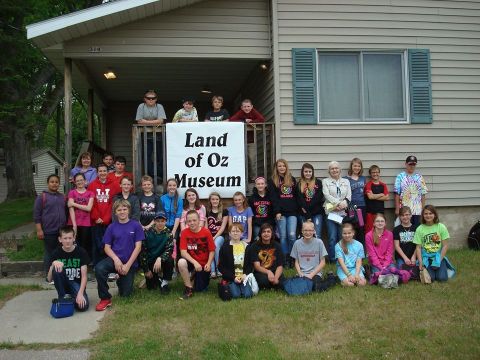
xmin=88 ymin=178 xmax=121 ymax=225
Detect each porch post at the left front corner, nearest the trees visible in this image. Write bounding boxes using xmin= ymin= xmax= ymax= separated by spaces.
xmin=64 ymin=58 xmax=72 ymax=191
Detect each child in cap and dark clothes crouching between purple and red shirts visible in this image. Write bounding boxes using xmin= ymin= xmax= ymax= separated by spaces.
xmin=140 ymin=211 xmax=173 ymax=294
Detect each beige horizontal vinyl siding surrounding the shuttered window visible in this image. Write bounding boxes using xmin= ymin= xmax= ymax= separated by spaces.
xmin=273 ymin=0 xmax=480 ymax=206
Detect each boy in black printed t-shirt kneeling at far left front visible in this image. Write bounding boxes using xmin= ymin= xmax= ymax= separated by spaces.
xmin=47 ymin=225 xmax=89 ymax=311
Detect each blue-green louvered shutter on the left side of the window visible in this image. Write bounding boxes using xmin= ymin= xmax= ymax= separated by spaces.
xmin=292 ymin=49 xmax=318 ymax=125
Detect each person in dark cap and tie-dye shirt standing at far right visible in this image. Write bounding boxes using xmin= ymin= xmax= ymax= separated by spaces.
xmin=394 ymin=155 xmax=428 ymax=225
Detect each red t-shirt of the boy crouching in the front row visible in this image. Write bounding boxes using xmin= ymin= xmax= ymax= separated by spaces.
xmin=180 ymin=227 xmax=215 ymax=266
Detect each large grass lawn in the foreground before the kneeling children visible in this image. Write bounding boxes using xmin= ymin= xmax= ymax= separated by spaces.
xmin=87 ymin=250 xmax=480 ymax=360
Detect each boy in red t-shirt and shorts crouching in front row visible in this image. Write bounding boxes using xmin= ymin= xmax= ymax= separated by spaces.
xmin=178 ymin=210 xmax=215 ymax=300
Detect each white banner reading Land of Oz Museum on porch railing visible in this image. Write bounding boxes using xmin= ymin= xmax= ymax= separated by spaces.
xmin=166 ymin=122 xmax=246 ymax=199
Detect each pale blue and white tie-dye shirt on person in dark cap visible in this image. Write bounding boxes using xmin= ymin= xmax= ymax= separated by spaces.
xmin=394 ymin=171 xmax=428 ymax=215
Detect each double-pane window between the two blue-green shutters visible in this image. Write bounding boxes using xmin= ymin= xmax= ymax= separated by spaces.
xmin=318 ymin=51 xmax=407 ymax=122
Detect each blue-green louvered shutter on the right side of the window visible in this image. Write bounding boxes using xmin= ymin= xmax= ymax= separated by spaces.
xmin=408 ymin=49 xmax=432 ymax=124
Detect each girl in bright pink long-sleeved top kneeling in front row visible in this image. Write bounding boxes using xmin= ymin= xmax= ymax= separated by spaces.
xmin=365 ymin=213 xmax=394 ymax=273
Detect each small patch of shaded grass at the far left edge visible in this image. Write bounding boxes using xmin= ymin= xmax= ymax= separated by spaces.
xmin=0 ymin=198 xmax=34 ymax=233
